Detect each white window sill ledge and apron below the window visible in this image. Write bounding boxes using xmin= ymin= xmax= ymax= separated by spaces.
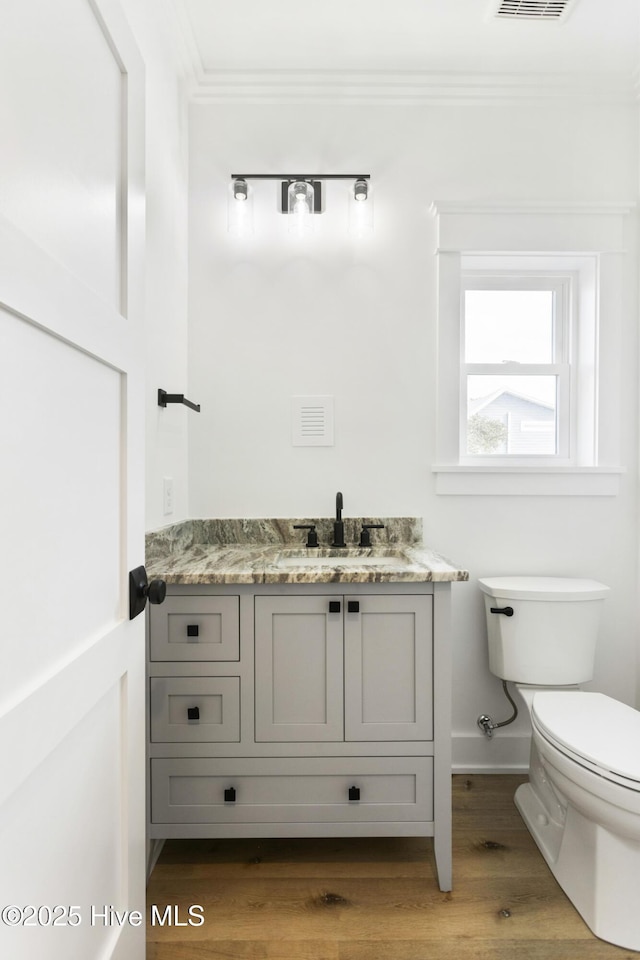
xmin=432 ymin=464 xmax=624 ymax=497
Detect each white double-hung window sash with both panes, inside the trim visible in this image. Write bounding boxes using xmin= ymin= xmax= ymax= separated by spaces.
xmin=460 ymin=271 xmax=576 ymax=463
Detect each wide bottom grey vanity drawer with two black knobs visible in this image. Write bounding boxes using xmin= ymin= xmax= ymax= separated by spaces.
xmin=151 ymin=757 xmax=433 ymax=824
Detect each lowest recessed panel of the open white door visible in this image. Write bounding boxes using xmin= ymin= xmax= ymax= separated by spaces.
xmin=0 ymin=682 xmax=126 ymax=960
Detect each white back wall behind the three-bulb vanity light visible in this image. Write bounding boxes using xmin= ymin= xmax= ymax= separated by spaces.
xmin=189 ymin=102 xmax=638 ymax=766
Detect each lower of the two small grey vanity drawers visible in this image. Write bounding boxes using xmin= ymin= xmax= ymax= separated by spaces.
xmin=150 ymin=677 xmax=240 ymax=743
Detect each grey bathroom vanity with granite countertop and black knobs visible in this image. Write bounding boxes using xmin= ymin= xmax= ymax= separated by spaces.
xmin=147 ymin=519 xmax=468 ymax=890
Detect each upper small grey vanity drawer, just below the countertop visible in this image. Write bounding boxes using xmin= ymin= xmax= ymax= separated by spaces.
xmin=149 ymin=596 xmax=240 ymax=660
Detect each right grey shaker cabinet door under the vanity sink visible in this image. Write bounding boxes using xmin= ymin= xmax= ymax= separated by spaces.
xmin=344 ymin=595 xmax=433 ymax=740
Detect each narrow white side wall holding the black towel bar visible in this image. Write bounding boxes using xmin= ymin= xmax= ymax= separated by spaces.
xmin=122 ymin=0 xmax=189 ymax=530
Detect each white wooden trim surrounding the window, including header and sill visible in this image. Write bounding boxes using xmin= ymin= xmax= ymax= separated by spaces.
xmin=431 ymin=201 xmax=636 ymax=496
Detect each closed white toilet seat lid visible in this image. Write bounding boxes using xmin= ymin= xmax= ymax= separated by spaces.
xmin=532 ymin=690 xmax=640 ymax=790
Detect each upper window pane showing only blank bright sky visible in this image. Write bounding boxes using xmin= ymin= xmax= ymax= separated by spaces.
xmin=464 ymin=290 xmax=554 ymax=363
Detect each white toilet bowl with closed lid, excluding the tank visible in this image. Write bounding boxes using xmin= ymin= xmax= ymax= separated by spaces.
xmin=515 ymin=691 xmax=640 ymax=951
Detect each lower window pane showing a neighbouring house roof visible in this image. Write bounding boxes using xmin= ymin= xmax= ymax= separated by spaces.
xmin=467 ymin=376 xmax=558 ymax=456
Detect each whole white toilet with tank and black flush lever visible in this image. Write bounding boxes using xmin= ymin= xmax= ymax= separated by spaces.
xmin=479 ymin=577 xmax=640 ymax=951
